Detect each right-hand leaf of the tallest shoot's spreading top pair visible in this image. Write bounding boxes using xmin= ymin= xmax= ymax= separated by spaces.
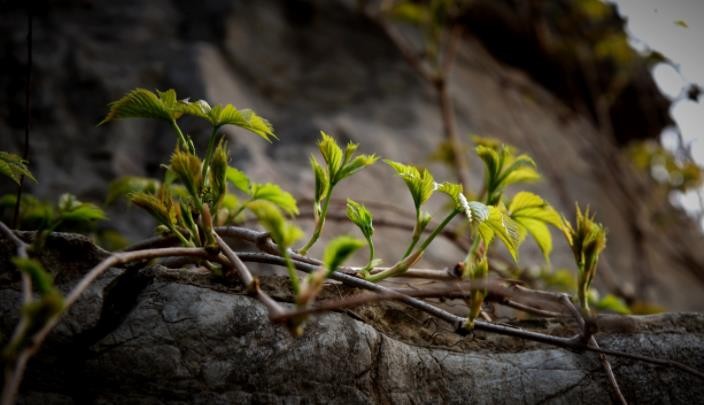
xmin=183 ymin=100 xmax=277 ymax=142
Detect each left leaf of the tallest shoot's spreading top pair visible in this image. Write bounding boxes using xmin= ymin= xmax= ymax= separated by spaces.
xmin=98 ymin=88 xmax=183 ymax=125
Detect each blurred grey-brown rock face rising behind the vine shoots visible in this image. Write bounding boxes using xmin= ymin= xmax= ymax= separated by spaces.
xmin=0 ymin=0 xmax=704 ymax=310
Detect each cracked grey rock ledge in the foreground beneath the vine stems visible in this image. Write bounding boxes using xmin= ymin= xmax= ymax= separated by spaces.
xmin=0 ymin=232 xmax=704 ymax=404
